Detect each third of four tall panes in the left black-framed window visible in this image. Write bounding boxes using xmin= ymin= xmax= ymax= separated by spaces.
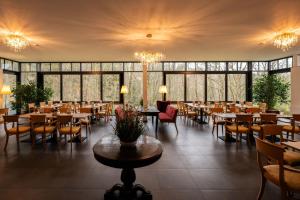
xmin=82 ymin=74 xmax=101 ymax=101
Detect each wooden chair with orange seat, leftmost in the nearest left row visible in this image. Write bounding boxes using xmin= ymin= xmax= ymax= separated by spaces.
xmin=3 ymin=115 xmax=30 ymax=151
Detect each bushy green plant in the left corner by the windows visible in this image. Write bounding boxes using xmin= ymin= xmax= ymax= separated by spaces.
xmin=11 ymin=81 xmax=53 ymax=113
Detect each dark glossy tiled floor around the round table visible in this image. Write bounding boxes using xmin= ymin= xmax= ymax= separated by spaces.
xmin=0 ymin=119 xmax=296 ymax=200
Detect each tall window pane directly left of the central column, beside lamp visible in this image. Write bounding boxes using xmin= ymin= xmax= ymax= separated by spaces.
xmin=124 ymin=72 xmax=143 ymax=106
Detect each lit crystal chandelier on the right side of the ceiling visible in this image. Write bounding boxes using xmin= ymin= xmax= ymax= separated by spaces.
xmin=273 ymin=33 xmax=298 ymax=51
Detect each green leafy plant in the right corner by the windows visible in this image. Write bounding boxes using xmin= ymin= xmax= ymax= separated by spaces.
xmin=253 ymin=75 xmax=290 ymax=109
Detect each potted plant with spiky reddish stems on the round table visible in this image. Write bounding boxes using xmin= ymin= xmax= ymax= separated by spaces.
xmin=113 ymin=108 xmax=145 ymax=147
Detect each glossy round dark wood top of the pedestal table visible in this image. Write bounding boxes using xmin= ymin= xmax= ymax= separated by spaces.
xmin=93 ymin=135 xmax=163 ymax=169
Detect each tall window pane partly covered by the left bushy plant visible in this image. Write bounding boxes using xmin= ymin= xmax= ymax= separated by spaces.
xmin=44 ymin=75 xmax=60 ymax=101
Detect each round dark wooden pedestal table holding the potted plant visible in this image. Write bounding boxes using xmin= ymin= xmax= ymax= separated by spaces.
xmin=93 ymin=135 xmax=163 ymax=200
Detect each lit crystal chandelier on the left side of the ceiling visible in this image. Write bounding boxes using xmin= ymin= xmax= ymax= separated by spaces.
xmin=4 ymin=32 xmax=30 ymax=52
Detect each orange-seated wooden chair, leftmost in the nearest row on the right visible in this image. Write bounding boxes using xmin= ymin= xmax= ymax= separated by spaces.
xmin=225 ymin=114 xmax=253 ymax=144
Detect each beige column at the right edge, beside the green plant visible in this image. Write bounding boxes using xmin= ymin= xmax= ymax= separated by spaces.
xmin=291 ymin=55 xmax=300 ymax=114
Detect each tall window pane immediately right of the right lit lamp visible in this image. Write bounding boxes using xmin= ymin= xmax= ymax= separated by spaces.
xmin=166 ymin=74 xmax=184 ymax=101
